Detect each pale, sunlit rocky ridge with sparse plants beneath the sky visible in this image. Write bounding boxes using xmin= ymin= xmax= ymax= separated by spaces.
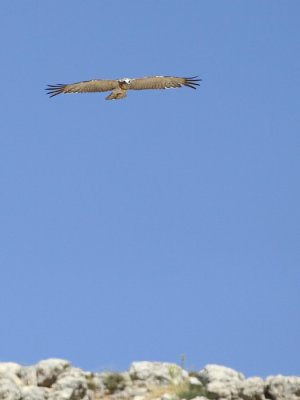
xmin=0 ymin=359 xmax=300 ymax=400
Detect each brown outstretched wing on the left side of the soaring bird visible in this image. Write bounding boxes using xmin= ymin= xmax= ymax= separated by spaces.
xmin=46 ymin=79 xmax=119 ymax=97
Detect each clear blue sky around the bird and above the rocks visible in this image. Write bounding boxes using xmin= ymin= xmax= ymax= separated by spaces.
xmin=0 ymin=0 xmax=300 ymax=376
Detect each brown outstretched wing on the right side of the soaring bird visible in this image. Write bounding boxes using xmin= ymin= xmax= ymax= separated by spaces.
xmin=129 ymin=76 xmax=201 ymax=90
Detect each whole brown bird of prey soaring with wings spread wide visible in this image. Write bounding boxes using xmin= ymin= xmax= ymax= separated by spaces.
xmin=46 ymin=76 xmax=201 ymax=100
